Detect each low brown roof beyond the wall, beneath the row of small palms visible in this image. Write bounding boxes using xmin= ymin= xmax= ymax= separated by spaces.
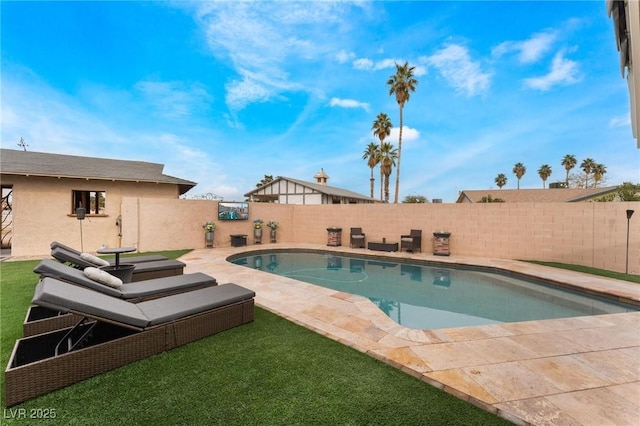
xmin=456 ymin=186 xmax=617 ymax=203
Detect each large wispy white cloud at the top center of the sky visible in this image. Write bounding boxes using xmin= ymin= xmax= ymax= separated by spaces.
xmin=194 ymin=2 xmax=352 ymax=111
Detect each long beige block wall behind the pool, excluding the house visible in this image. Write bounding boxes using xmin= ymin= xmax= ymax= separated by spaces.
xmin=122 ymin=198 xmax=640 ymax=274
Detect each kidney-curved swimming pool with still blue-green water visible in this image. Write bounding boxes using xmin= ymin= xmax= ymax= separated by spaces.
xmin=229 ymin=250 xmax=639 ymax=329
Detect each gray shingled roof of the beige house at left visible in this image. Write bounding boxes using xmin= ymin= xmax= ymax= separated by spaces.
xmin=0 ymin=149 xmax=196 ymax=194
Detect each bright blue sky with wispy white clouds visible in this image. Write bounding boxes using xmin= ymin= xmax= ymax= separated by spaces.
xmin=0 ymin=1 xmax=640 ymax=202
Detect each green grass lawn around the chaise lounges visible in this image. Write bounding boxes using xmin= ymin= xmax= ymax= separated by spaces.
xmin=0 ymin=252 xmax=509 ymax=425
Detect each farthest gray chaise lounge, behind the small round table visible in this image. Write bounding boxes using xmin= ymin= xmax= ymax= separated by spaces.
xmin=51 ymin=247 xmax=186 ymax=282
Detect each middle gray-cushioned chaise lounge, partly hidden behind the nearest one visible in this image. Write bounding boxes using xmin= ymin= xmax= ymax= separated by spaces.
xmin=22 ymin=259 xmax=217 ymax=337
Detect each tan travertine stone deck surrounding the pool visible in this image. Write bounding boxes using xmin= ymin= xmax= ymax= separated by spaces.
xmin=181 ymin=244 xmax=640 ymax=426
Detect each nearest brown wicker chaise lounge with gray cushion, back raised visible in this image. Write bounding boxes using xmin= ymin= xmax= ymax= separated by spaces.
xmin=5 ymin=278 xmax=255 ymax=406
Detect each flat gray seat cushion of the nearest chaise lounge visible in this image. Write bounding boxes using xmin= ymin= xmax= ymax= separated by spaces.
xmin=137 ymin=284 xmax=255 ymax=325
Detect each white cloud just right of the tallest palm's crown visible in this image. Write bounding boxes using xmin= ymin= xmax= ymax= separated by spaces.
xmin=423 ymin=44 xmax=491 ymax=96
